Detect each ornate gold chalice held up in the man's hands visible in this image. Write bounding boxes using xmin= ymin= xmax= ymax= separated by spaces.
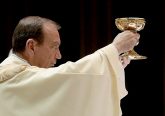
xmin=115 ymin=17 xmax=147 ymax=60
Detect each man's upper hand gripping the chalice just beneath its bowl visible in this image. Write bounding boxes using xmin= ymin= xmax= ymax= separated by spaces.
xmin=112 ymin=30 xmax=140 ymax=54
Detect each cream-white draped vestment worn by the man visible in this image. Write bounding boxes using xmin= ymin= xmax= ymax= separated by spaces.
xmin=0 ymin=44 xmax=127 ymax=116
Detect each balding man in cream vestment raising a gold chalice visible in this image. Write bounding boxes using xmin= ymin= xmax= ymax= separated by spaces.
xmin=0 ymin=16 xmax=140 ymax=116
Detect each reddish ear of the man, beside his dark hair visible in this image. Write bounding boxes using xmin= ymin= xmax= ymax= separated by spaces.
xmin=25 ymin=39 xmax=37 ymax=56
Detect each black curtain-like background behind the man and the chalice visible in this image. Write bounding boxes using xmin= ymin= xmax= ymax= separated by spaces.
xmin=0 ymin=0 xmax=165 ymax=116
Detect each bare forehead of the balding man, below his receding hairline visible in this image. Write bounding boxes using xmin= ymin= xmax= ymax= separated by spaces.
xmin=43 ymin=23 xmax=61 ymax=44
